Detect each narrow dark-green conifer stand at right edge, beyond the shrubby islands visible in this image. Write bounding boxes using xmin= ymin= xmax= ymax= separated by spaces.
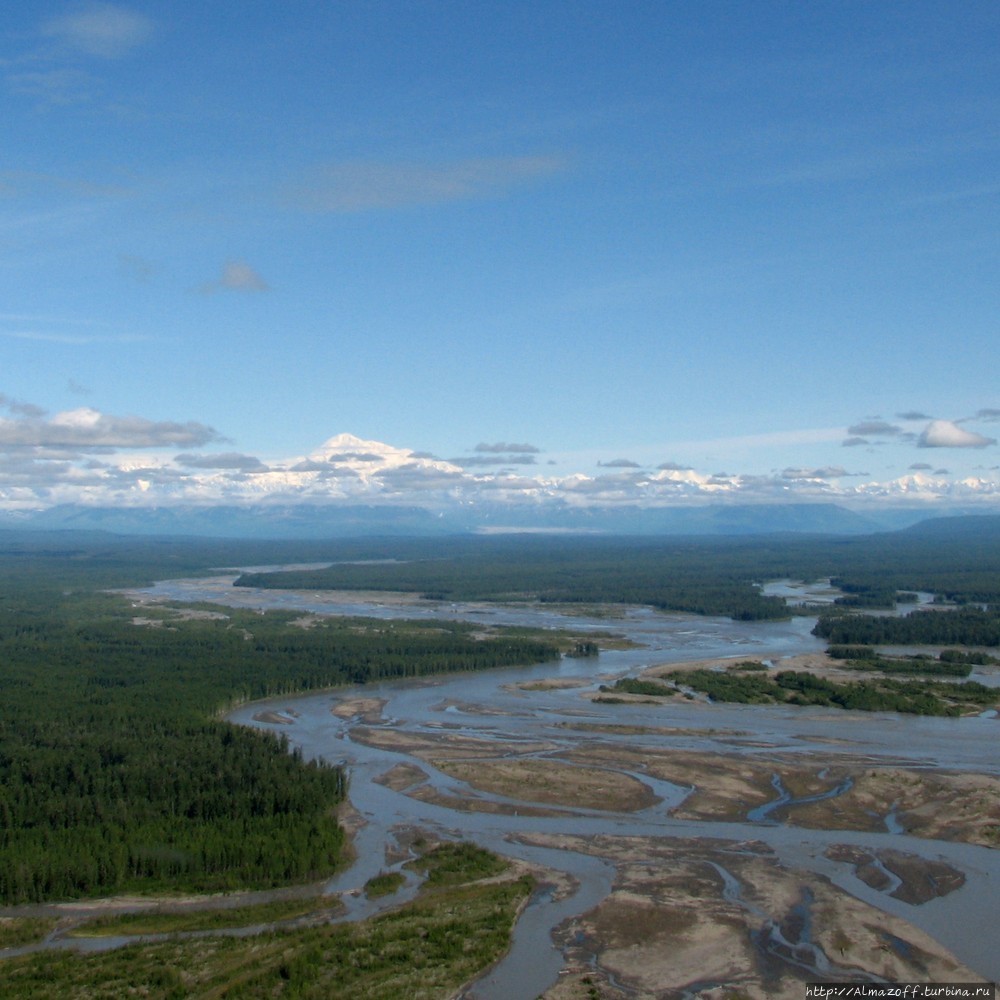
xmin=813 ymin=607 xmax=1000 ymax=646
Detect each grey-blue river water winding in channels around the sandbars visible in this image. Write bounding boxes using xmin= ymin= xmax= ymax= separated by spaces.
xmin=133 ymin=576 xmax=1000 ymax=1000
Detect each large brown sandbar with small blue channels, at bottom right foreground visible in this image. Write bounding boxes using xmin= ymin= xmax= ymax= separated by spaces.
xmin=520 ymin=834 xmax=980 ymax=1000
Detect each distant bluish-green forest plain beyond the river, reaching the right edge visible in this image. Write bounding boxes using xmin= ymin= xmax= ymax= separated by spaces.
xmin=237 ymin=518 xmax=1000 ymax=620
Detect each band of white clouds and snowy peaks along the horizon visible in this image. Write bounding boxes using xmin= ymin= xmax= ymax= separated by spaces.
xmin=0 ymin=404 xmax=1000 ymax=511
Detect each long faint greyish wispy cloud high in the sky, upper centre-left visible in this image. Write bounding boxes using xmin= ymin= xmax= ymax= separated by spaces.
xmin=288 ymin=155 xmax=566 ymax=212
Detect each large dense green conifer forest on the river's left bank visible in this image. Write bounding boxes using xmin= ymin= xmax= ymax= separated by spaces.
xmin=0 ymin=560 xmax=558 ymax=903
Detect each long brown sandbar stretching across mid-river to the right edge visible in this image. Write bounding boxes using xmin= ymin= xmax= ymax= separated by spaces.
xmin=352 ymin=727 xmax=1000 ymax=847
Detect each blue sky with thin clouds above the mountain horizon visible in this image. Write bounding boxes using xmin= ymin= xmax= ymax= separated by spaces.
xmin=0 ymin=0 xmax=1000 ymax=507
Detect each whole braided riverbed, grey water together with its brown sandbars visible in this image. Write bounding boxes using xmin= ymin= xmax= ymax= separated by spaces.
xmin=137 ymin=577 xmax=1000 ymax=1000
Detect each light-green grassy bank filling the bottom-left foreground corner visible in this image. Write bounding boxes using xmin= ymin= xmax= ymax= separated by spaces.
xmin=0 ymin=845 xmax=534 ymax=1000
